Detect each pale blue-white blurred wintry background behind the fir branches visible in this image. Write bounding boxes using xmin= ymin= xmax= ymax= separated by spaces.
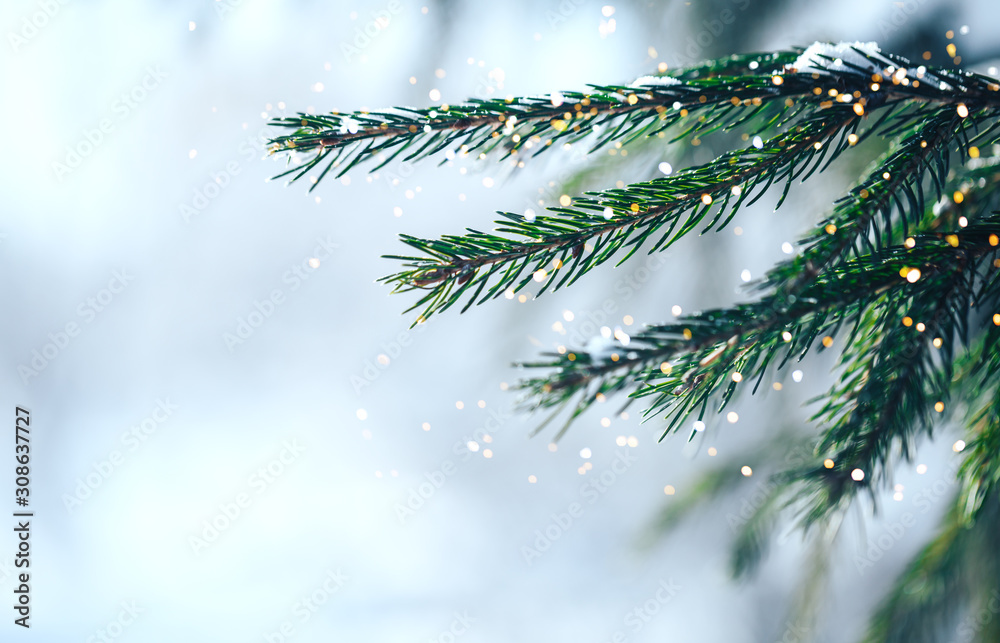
xmin=0 ymin=0 xmax=1000 ymax=643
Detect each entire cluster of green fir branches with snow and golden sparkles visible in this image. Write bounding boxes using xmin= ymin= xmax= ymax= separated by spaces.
xmin=272 ymin=43 xmax=1000 ymax=641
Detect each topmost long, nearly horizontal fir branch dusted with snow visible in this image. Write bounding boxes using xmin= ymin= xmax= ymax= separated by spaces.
xmin=271 ymin=45 xmax=1000 ymax=190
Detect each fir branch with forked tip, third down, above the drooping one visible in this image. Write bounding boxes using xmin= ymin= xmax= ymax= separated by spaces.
xmin=520 ymin=220 xmax=1000 ymax=439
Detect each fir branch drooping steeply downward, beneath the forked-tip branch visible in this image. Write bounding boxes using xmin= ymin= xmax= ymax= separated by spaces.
xmin=790 ymin=270 xmax=969 ymax=525
